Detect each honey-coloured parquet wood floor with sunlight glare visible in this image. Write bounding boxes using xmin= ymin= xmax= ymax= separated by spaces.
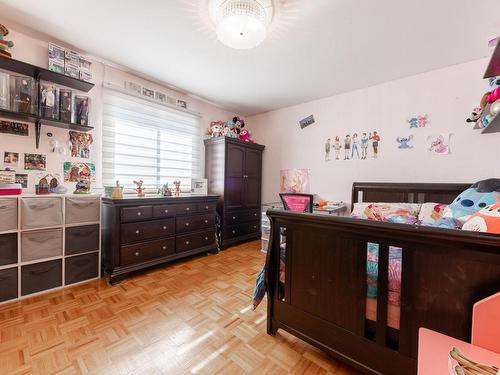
xmin=0 ymin=241 xmax=357 ymax=375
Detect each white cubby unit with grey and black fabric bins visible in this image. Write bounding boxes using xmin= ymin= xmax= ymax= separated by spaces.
xmin=0 ymin=195 xmax=101 ymax=303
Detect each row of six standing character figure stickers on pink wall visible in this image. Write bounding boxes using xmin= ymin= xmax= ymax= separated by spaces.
xmin=325 ymin=131 xmax=382 ymax=162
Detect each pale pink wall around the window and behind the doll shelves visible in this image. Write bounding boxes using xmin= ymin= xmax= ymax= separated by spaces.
xmin=0 ymin=28 xmax=233 ymax=192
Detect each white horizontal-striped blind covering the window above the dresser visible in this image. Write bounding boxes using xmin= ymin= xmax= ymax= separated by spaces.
xmin=102 ymin=89 xmax=202 ymax=192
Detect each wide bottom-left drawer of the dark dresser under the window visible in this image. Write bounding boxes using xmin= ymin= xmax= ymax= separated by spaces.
xmin=120 ymin=238 xmax=175 ymax=266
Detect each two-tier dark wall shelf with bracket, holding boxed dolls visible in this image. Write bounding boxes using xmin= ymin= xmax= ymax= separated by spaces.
xmin=0 ymin=55 xmax=94 ymax=149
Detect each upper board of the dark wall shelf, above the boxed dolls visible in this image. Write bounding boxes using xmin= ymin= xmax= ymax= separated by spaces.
xmin=0 ymin=55 xmax=94 ymax=92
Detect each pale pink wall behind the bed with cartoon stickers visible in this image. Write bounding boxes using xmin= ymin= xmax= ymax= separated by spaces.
xmin=247 ymin=59 xmax=500 ymax=206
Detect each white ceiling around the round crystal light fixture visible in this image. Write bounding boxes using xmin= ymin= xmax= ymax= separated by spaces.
xmin=0 ymin=0 xmax=500 ymax=115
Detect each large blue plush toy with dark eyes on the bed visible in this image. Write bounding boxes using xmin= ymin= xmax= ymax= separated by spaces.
xmin=444 ymin=178 xmax=500 ymax=223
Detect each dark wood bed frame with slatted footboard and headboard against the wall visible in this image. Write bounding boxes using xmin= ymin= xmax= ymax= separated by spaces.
xmin=266 ymin=183 xmax=500 ymax=375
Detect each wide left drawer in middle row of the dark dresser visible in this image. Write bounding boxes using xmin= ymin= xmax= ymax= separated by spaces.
xmin=121 ymin=218 xmax=175 ymax=243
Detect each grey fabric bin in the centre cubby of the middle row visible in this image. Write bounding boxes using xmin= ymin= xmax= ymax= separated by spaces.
xmin=21 ymin=229 xmax=62 ymax=262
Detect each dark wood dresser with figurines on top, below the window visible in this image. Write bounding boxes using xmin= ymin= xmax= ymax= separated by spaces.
xmin=102 ymin=195 xmax=218 ymax=283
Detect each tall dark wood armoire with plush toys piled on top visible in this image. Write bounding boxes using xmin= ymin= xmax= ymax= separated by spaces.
xmin=205 ymin=137 xmax=265 ymax=248
